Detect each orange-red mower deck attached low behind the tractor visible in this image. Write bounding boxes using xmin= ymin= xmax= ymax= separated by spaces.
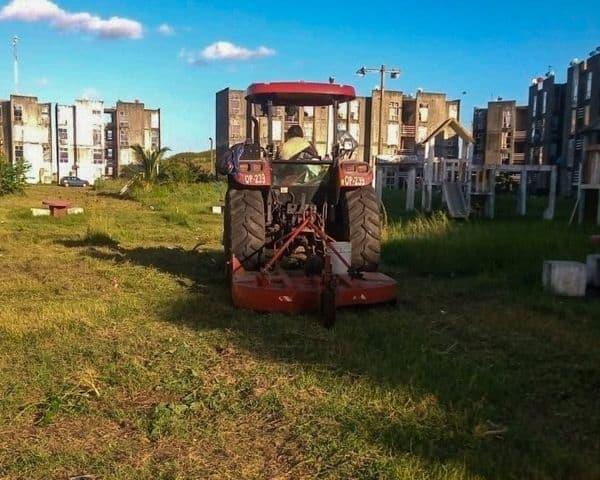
xmin=231 ymin=258 xmax=397 ymax=313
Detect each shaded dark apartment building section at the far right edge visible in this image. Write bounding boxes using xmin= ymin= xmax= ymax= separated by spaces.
xmin=561 ymin=50 xmax=600 ymax=187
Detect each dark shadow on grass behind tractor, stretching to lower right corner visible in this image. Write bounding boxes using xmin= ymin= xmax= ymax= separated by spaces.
xmin=61 ymin=243 xmax=600 ymax=478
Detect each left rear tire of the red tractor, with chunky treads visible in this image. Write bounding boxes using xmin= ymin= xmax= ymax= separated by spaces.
xmin=223 ymin=188 xmax=265 ymax=271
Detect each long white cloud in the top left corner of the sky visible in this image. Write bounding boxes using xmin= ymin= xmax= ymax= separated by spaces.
xmin=0 ymin=0 xmax=143 ymax=39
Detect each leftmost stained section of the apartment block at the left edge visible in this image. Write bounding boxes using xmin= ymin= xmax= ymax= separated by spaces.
xmin=0 ymin=95 xmax=53 ymax=183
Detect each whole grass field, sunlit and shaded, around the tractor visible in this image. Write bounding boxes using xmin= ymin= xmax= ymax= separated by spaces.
xmin=0 ymin=184 xmax=600 ymax=480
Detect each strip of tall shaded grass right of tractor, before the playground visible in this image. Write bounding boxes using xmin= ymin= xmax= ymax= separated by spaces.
xmin=383 ymin=190 xmax=591 ymax=284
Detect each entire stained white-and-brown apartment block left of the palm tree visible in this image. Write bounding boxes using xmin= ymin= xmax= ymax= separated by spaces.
xmin=0 ymin=95 xmax=161 ymax=183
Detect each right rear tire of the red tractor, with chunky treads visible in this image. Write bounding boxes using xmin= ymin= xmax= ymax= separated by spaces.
xmin=341 ymin=186 xmax=381 ymax=272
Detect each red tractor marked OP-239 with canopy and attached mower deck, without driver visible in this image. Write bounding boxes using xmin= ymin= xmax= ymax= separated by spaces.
xmin=219 ymin=82 xmax=396 ymax=326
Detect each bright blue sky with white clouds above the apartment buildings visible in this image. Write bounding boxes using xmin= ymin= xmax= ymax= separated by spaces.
xmin=0 ymin=0 xmax=600 ymax=151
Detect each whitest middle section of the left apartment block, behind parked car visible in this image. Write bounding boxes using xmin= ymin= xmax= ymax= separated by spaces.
xmin=56 ymin=100 xmax=109 ymax=183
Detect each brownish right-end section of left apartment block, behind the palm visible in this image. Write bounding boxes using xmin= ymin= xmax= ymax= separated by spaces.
xmin=104 ymin=100 xmax=161 ymax=175
